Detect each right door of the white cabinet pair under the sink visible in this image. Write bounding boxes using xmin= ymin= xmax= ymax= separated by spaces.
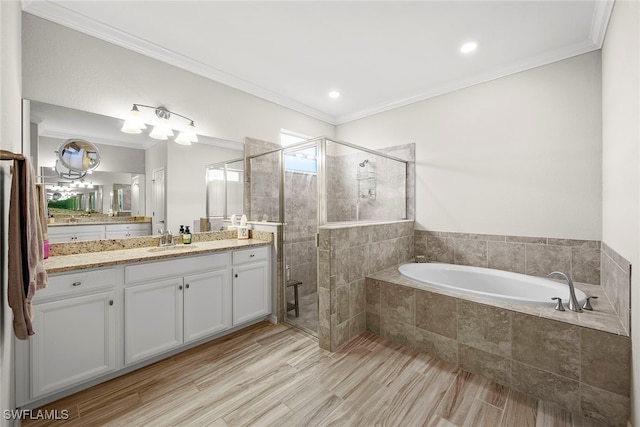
xmin=184 ymin=269 xmax=231 ymax=342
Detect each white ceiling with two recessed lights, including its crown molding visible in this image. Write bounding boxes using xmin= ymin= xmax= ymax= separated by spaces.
xmin=23 ymin=0 xmax=613 ymax=124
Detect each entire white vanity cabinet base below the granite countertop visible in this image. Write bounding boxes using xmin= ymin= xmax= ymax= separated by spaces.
xmin=14 ymin=246 xmax=272 ymax=407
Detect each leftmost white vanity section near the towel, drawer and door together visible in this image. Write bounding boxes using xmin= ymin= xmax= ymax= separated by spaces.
xmin=24 ymin=268 xmax=119 ymax=400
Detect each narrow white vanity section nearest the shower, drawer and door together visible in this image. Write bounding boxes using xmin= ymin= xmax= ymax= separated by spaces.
xmin=233 ymin=246 xmax=271 ymax=325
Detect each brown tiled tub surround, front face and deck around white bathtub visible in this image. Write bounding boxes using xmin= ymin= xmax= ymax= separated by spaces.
xmin=366 ymin=268 xmax=631 ymax=426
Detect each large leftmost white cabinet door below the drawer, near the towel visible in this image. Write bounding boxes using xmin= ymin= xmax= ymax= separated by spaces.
xmin=31 ymin=291 xmax=118 ymax=399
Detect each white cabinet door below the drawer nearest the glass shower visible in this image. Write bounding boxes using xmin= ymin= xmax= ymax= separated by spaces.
xmin=233 ymin=262 xmax=271 ymax=326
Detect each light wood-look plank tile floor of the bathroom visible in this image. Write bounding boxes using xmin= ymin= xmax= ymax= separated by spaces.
xmin=23 ymin=323 xmax=598 ymax=427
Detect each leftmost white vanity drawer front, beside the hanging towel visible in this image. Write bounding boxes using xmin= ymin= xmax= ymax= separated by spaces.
xmin=34 ymin=268 xmax=116 ymax=302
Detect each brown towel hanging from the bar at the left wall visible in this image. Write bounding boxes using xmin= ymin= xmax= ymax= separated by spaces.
xmin=8 ymin=159 xmax=47 ymax=340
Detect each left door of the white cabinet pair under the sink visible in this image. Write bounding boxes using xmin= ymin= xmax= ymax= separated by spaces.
xmin=124 ymin=279 xmax=183 ymax=365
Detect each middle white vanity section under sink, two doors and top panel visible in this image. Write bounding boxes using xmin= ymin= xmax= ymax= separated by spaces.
xmin=124 ymin=253 xmax=231 ymax=365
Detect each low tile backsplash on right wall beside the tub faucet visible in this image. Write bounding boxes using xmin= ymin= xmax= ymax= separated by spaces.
xmin=601 ymin=242 xmax=631 ymax=333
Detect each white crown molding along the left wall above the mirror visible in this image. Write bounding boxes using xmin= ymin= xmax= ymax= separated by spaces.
xmin=22 ymin=0 xmax=335 ymax=124
